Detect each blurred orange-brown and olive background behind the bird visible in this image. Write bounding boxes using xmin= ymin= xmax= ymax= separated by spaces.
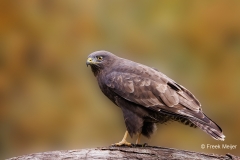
xmin=0 ymin=0 xmax=240 ymax=159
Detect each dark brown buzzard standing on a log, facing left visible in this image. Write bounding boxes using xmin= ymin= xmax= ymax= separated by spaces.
xmin=86 ymin=51 xmax=225 ymax=146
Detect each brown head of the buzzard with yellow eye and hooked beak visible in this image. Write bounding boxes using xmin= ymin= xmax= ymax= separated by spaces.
xmin=86 ymin=51 xmax=117 ymax=76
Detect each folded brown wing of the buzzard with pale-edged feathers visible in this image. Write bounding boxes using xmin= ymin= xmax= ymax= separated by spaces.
xmin=105 ymin=65 xmax=201 ymax=114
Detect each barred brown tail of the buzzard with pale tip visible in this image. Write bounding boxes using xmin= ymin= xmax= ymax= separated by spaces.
xmin=190 ymin=115 xmax=225 ymax=141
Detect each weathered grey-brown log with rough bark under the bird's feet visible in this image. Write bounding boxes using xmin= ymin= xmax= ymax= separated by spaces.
xmin=8 ymin=146 xmax=240 ymax=160
